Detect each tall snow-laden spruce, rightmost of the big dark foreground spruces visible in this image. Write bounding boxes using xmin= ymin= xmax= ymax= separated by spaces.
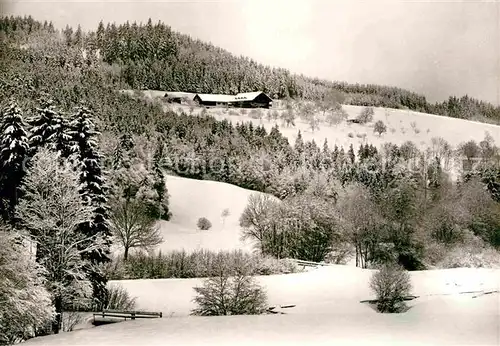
xmin=69 ymin=107 xmax=111 ymax=305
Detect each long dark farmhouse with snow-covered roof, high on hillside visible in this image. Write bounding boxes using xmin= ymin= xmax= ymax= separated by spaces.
xmin=194 ymin=91 xmax=273 ymax=108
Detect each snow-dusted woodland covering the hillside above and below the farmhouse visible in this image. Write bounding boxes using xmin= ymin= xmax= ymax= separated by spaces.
xmin=0 ymin=17 xmax=500 ymax=344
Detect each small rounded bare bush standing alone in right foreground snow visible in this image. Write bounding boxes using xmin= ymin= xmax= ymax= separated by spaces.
xmin=370 ymin=264 xmax=411 ymax=313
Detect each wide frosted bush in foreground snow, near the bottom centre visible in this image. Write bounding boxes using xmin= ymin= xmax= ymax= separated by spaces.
xmin=192 ymin=259 xmax=267 ymax=316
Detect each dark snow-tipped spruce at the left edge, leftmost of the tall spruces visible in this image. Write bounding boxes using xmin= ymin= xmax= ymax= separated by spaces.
xmin=0 ymin=101 xmax=29 ymax=221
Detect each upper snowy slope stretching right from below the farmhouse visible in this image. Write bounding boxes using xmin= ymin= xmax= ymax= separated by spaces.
xmin=160 ymin=98 xmax=500 ymax=177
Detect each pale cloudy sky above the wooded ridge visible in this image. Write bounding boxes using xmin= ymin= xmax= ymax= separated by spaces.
xmin=2 ymin=0 xmax=500 ymax=105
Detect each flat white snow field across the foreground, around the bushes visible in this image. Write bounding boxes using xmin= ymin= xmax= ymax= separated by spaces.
xmin=23 ymin=266 xmax=500 ymax=346
